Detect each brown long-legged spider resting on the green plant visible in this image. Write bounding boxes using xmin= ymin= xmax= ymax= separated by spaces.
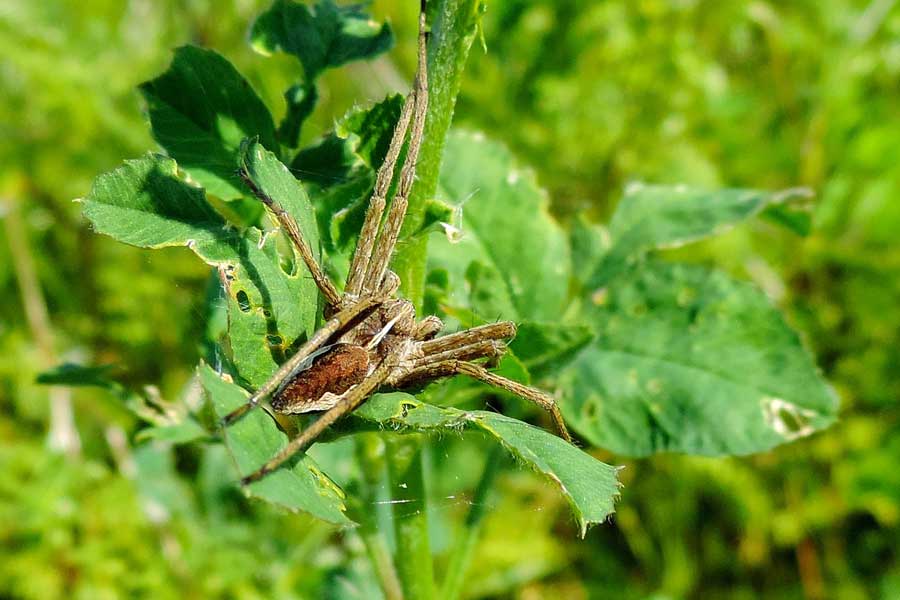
xmin=223 ymin=0 xmax=571 ymax=485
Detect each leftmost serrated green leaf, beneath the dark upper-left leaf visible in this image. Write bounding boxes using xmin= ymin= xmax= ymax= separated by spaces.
xmin=80 ymin=154 xmax=238 ymax=260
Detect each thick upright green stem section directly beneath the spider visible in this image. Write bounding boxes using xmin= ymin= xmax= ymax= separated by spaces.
xmin=385 ymin=435 xmax=435 ymax=600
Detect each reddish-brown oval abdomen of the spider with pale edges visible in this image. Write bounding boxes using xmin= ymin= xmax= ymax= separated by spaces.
xmin=272 ymin=344 xmax=369 ymax=414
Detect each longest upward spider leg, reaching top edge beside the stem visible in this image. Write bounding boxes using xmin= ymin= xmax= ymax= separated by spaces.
xmin=362 ymin=1 xmax=428 ymax=290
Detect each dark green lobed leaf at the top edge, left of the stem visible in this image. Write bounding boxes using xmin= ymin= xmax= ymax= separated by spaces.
xmin=250 ymin=0 xmax=394 ymax=82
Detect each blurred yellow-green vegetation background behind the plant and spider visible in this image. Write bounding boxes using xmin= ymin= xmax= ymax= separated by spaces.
xmin=0 ymin=0 xmax=900 ymax=599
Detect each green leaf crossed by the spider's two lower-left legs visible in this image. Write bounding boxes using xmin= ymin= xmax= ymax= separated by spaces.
xmin=199 ymin=364 xmax=352 ymax=525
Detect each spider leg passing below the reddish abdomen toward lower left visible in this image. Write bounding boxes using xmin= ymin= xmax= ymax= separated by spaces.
xmin=241 ymin=355 xmax=396 ymax=485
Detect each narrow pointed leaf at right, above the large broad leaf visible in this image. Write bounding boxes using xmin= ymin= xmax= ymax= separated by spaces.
xmin=588 ymin=183 xmax=808 ymax=289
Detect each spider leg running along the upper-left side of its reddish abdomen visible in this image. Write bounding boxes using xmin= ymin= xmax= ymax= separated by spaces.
xmin=222 ymin=278 xmax=399 ymax=426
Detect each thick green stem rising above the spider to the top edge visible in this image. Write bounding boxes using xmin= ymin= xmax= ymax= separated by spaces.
xmin=392 ymin=0 xmax=482 ymax=309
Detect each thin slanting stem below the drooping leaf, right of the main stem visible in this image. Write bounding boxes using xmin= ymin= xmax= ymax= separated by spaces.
xmin=441 ymin=446 xmax=503 ymax=600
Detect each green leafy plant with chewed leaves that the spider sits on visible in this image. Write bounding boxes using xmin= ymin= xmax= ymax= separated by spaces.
xmin=59 ymin=0 xmax=837 ymax=597
